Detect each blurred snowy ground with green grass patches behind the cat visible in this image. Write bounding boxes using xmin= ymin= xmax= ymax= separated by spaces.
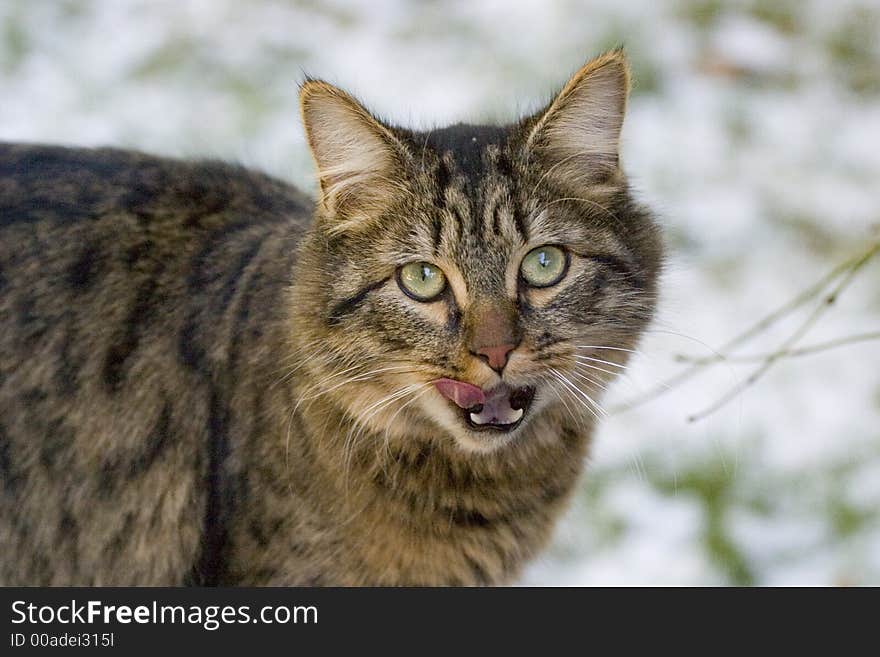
xmin=0 ymin=0 xmax=880 ymax=585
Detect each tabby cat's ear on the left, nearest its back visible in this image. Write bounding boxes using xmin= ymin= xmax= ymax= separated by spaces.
xmin=299 ymin=80 xmax=404 ymax=232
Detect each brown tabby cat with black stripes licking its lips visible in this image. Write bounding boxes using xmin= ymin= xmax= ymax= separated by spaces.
xmin=0 ymin=50 xmax=662 ymax=586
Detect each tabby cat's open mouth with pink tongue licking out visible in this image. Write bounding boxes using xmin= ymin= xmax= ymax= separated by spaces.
xmin=434 ymin=379 xmax=535 ymax=433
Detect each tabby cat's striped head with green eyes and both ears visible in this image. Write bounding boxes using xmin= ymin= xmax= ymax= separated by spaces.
xmin=294 ymin=51 xmax=661 ymax=452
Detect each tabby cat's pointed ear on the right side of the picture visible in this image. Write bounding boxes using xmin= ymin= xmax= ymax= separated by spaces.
xmin=526 ymin=49 xmax=629 ymax=186
